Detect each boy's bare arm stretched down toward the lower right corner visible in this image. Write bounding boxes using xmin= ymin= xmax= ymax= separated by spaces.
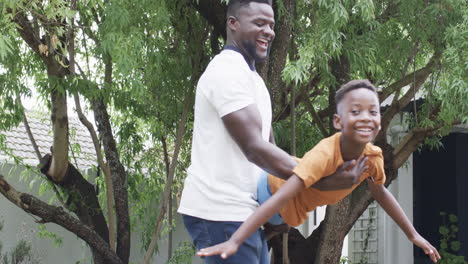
xmin=367 ymin=179 xmax=440 ymax=263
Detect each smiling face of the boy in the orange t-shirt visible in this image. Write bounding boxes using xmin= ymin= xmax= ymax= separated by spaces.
xmin=333 ymin=88 xmax=380 ymax=144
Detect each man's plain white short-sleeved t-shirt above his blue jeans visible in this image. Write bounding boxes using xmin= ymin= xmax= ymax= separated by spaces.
xmin=178 ymin=50 xmax=272 ymax=221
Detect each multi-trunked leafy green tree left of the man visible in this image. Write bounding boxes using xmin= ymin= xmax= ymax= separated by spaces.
xmin=0 ymin=0 xmax=208 ymax=263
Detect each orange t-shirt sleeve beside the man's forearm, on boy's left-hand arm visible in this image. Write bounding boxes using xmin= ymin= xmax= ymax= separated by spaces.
xmin=293 ymin=145 xmax=331 ymax=188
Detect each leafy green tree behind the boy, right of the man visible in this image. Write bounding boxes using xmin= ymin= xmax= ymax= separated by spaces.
xmin=193 ymin=0 xmax=468 ymax=263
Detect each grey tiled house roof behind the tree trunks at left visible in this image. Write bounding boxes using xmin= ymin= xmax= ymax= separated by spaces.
xmin=0 ymin=111 xmax=97 ymax=170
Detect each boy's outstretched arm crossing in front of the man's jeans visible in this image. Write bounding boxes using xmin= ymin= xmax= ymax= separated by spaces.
xmin=197 ymin=175 xmax=305 ymax=258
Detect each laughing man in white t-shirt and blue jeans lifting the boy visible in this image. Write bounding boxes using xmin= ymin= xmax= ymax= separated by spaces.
xmin=178 ymin=0 xmax=365 ymax=264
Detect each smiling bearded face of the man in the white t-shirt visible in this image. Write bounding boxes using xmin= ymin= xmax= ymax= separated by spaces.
xmin=230 ymin=2 xmax=275 ymax=62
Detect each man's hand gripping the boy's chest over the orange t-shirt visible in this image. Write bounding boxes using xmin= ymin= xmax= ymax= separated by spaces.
xmin=311 ymin=156 xmax=368 ymax=191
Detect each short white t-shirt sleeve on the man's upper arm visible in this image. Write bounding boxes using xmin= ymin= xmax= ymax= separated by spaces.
xmin=199 ymin=69 xmax=254 ymax=117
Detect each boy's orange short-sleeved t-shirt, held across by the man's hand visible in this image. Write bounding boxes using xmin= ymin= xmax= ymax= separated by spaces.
xmin=268 ymin=132 xmax=385 ymax=226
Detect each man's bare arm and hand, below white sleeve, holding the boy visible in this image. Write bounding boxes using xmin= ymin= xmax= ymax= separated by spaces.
xmin=222 ymin=105 xmax=367 ymax=191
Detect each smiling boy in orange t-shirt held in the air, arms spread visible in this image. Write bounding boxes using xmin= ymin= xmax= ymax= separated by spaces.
xmin=197 ymin=80 xmax=440 ymax=263
